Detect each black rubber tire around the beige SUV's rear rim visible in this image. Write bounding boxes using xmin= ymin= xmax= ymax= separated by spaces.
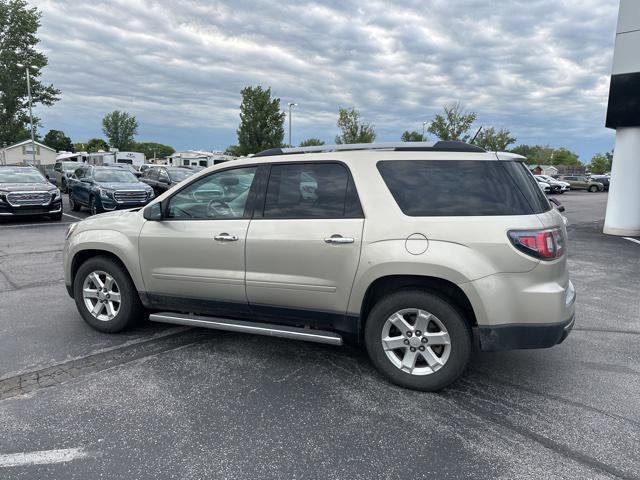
xmin=364 ymin=290 xmax=472 ymax=392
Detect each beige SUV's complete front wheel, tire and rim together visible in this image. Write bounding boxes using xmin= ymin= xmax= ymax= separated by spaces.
xmin=73 ymin=257 xmax=144 ymax=333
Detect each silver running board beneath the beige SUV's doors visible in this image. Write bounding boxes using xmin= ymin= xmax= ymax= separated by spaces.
xmin=149 ymin=312 xmax=342 ymax=345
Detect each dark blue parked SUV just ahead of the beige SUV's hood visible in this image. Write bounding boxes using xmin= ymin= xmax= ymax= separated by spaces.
xmin=69 ymin=165 xmax=155 ymax=215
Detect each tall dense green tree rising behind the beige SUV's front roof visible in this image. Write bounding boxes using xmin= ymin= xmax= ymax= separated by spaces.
xmin=235 ymin=85 xmax=285 ymax=156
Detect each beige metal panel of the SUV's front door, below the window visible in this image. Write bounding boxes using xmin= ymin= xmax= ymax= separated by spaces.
xmin=140 ymin=219 xmax=249 ymax=304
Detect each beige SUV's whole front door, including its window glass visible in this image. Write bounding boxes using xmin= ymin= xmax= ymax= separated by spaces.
xmin=139 ymin=167 xmax=257 ymax=312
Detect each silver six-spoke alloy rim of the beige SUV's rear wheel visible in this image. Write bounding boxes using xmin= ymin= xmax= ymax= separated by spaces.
xmin=381 ymin=308 xmax=451 ymax=375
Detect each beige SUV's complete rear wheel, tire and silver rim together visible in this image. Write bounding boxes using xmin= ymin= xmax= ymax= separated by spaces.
xmin=365 ymin=290 xmax=471 ymax=391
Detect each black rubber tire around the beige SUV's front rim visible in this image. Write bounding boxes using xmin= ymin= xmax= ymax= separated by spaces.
xmin=73 ymin=256 xmax=145 ymax=333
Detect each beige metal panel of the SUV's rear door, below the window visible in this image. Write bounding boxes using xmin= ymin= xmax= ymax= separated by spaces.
xmin=246 ymin=218 xmax=364 ymax=314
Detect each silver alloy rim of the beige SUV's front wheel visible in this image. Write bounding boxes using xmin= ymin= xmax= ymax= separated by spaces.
xmin=82 ymin=270 xmax=121 ymax=322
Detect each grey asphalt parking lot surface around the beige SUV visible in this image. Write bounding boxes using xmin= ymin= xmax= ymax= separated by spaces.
xmin=0 ymin=192 xmax=640 ymax=480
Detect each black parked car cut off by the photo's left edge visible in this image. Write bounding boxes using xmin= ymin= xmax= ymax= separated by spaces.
xmin=0 ymin=167 xmax=62 ymax=220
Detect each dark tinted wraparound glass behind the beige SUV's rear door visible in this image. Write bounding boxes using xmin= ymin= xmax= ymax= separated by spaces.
xmin=377 ymin=160 xmax=551 ymax=217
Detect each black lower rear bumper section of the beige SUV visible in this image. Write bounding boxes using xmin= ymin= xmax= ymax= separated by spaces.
xmin=475 ymin=315 xmax=575 ymax=352
